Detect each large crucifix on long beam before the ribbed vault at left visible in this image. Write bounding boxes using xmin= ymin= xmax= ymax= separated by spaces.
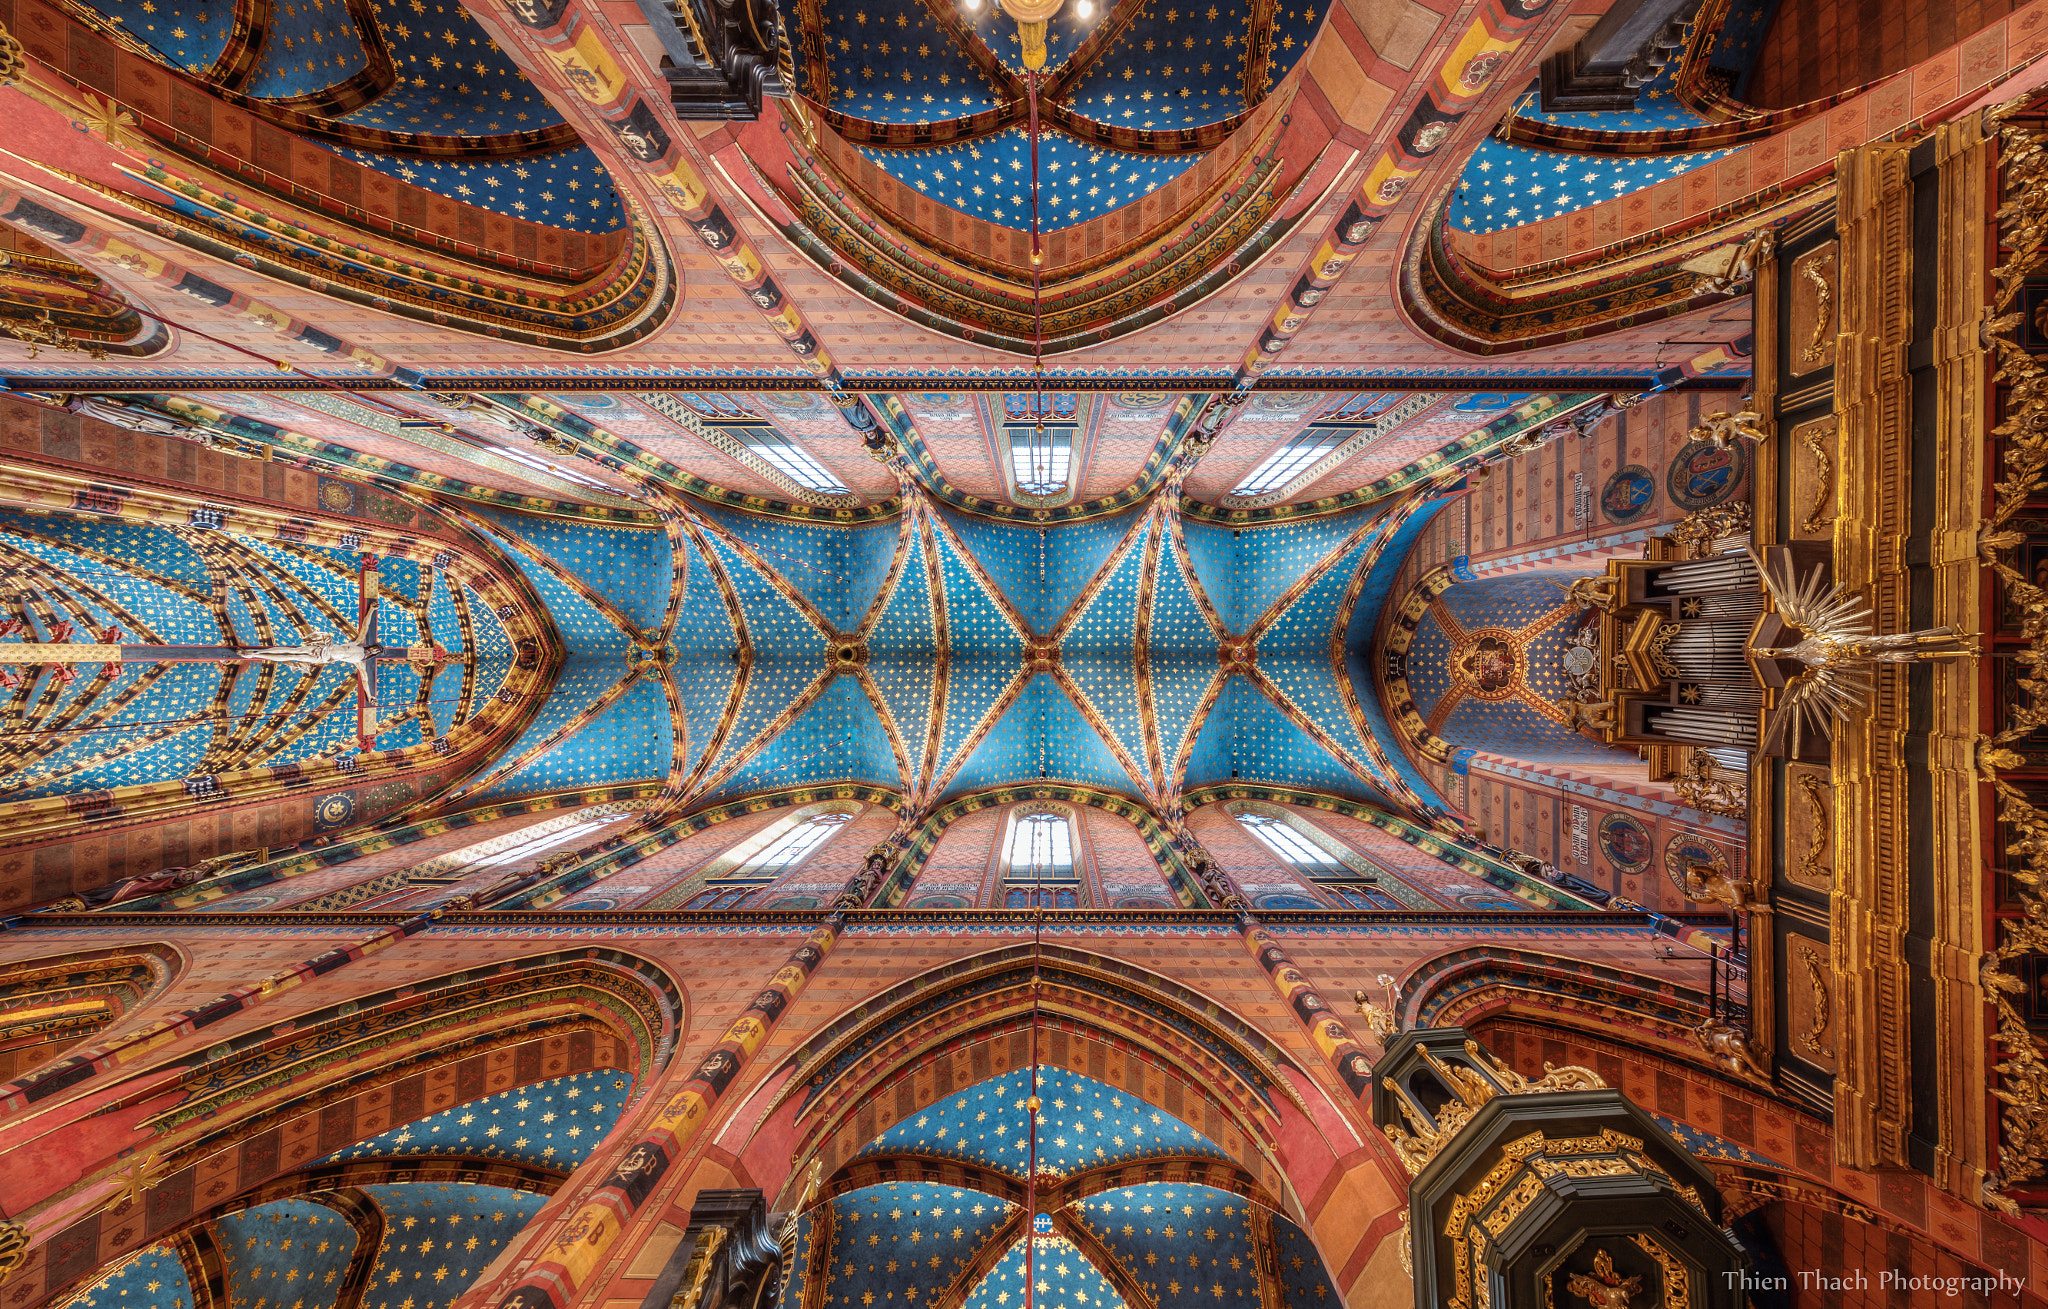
xmin=0 ymin=555 xmax=465 ymax=750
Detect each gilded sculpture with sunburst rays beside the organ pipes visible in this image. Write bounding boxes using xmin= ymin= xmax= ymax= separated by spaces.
xmin=1749 ymin=549 xmax=1976 ymax=756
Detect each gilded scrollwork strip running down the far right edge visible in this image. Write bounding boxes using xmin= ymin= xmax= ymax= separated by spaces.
xmin=1976 ymin=117 xmax=2048 ymax=1217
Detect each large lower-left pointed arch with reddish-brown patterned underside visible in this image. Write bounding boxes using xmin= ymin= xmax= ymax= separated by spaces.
xmin=0 ymin=948 xmax=688 ymax=1303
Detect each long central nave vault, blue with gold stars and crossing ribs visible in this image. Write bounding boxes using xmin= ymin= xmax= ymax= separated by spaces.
xmin=411 ymin=471 xmax=1438 ymax=813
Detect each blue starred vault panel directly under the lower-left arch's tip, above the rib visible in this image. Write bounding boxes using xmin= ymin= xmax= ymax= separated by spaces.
xmin=319 ymin=1069 xmax=633 ymax=1172
